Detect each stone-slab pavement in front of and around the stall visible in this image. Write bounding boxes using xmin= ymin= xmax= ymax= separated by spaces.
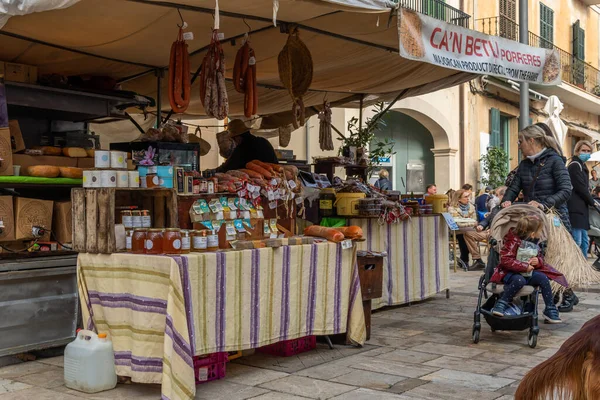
xmin=0 ymin=272 xmax=600 ymax=400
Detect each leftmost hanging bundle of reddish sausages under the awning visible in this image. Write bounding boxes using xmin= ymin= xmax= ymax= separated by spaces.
xmin=169 ymin=29 xmax=192 ymax=113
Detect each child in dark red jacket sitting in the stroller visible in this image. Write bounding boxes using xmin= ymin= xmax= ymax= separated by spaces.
xmin=490 ymin=216 xmax=568 ymax=324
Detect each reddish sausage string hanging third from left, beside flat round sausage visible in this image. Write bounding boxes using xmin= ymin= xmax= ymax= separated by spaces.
xmin=233 ymin=40 xmax=258 ymax=118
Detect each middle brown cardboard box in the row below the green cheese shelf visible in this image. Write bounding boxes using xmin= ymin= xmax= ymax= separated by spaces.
xmin=14 ymin=197 xmax=54 ymax=242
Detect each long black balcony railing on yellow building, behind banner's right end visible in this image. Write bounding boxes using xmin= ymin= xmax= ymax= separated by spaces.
xmin=475 ymin=17 xmax=600 ymax=96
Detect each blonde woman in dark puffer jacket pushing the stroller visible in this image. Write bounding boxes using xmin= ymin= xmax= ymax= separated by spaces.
xmin=502 ymin=123 xmax=571 ymax=232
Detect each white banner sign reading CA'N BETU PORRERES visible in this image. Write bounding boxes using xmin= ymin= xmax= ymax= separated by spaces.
xmin=398 ymin=8 xmax=561 ymax=85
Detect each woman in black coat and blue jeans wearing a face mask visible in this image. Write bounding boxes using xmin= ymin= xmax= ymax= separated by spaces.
xmin=567 ymin=140 xmax=595 ymax=258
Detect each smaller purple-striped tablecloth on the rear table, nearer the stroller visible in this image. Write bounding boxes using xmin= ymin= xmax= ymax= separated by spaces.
xmin=350 ymin=215 xmax=450 ymax=309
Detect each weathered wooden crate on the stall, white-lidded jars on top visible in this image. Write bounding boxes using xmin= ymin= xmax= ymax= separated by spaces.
xmin=71 ymin=188 xmax=179 ymax=254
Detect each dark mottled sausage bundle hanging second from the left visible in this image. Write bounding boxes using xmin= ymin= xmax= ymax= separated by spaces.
xmin=200 ymin=29 xmax=229 ymax=120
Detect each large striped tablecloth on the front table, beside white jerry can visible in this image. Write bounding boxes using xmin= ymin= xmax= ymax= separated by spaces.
xmin=78 ymin=243 xmax=366 ymax=400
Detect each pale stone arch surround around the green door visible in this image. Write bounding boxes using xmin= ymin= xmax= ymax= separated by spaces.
xmin=392 ymin=97 xmax=460 ymax=193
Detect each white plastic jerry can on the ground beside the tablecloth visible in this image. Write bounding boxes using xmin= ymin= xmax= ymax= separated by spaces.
xmin=64 ymin=330 xmax=117 ymax=393
